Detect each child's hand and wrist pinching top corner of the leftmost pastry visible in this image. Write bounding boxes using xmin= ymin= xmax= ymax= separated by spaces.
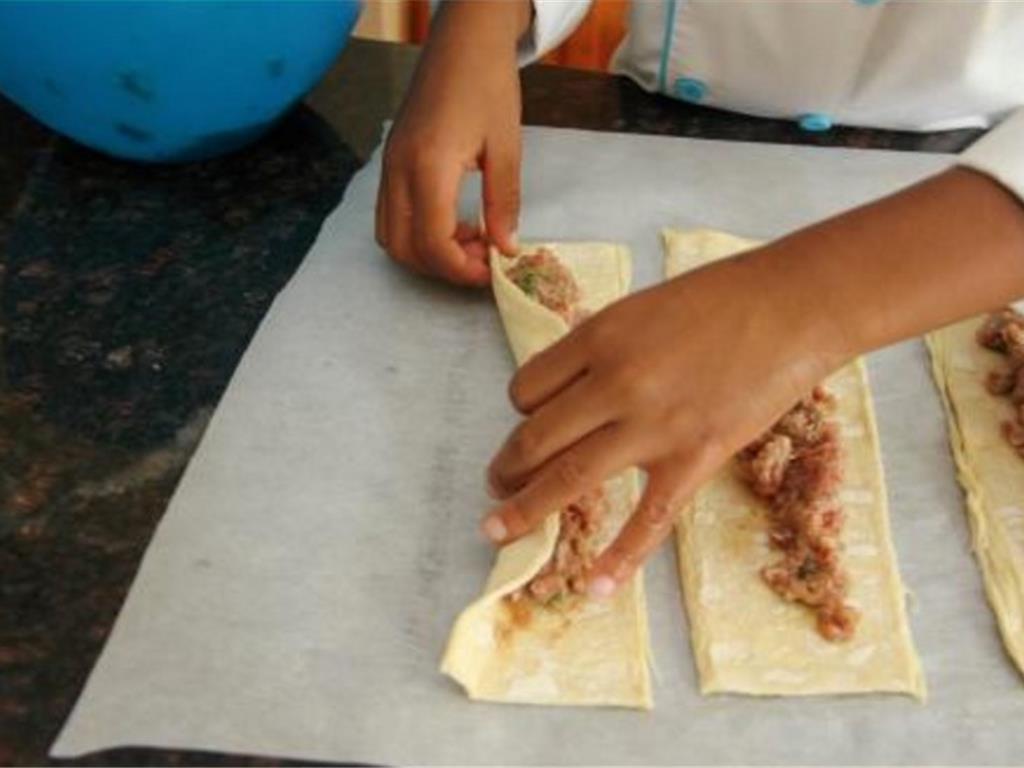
xmin=376 ymin=0 xmax=532 ymax=285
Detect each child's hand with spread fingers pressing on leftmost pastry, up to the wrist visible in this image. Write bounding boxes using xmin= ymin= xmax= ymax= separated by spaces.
xmin=483 ymin=252 xmax=839 ymax=596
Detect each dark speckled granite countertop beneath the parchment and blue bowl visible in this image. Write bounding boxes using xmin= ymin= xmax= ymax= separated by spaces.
xmin=0 ymin=41 xmax=977 ymax=765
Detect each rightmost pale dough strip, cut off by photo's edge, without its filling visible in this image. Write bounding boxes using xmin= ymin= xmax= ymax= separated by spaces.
xmin=926 ymin=317 xmax=1024 ymax=674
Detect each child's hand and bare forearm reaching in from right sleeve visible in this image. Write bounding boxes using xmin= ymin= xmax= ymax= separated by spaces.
xmin=475 ymin=168 xmax=1024 ymax=596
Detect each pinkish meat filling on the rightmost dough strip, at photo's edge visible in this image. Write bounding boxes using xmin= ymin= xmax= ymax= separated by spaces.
xmin=977 ymin=307 xmax=1024 ymax=457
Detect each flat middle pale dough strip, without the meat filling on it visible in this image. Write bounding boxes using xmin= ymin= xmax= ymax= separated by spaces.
xmin=663 ymin=229 xmax=925 ymax=699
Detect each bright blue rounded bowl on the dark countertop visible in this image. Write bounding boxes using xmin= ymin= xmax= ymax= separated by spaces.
xmin=0 ymin=0 xmax=360 ymax=162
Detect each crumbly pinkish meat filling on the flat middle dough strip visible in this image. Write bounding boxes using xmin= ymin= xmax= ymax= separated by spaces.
xmin=736 ymin=387 xmax=858 ymax=641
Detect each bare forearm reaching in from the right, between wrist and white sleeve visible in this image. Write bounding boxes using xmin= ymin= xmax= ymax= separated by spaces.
xmin=751 ymin=168 xmax=1024 ymax=367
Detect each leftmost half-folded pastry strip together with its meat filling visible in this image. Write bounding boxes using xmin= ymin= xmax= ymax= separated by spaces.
xmin=441 ymin=243 xmax=651 ymax=709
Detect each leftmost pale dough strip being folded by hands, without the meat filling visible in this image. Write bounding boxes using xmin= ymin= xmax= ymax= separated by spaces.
xmin=441 ymin=243 xmax=651 ymax=709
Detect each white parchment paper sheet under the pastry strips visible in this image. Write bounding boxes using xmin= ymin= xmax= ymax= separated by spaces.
xmin=53 ymin=129 xmax=1024 ymax=763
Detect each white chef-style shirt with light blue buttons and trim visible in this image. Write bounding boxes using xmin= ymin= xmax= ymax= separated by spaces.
xmin=520 ymin=0 xmax=1024 ymax=200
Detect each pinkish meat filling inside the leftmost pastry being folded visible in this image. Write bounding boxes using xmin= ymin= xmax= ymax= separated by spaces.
xmin=506 ymin=248 xmax=604 ymax=604
